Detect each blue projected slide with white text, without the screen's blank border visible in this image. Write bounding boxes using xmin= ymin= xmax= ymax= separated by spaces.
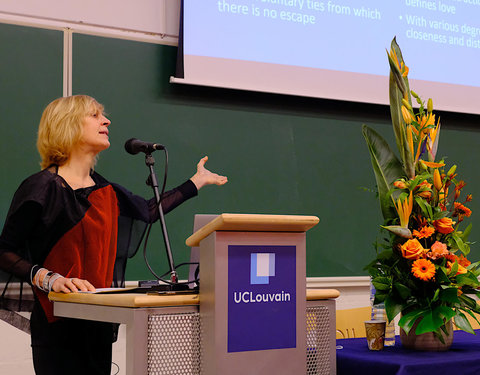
xmin=178 ymin=0 xmax=480 ymax=113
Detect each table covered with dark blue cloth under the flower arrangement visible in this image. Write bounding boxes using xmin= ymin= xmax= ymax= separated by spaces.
xmin=337 ymin=330 xmax=480 ymax=375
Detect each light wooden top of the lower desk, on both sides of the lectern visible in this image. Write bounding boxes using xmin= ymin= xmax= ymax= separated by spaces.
xmin=48 ymin=289 xmax=340 ymax=308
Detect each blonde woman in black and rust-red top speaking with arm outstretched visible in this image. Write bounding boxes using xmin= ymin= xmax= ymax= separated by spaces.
xmin=0 ymin=95 xmax=227 ymax=375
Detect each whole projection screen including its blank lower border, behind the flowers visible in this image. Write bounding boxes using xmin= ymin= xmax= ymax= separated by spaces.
xmin=171 ymin=0 xmax=480 ymax=114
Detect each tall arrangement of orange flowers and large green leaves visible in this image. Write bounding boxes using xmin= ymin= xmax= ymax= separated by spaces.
xmin=362 ymin=39 xmax=480 ymax=342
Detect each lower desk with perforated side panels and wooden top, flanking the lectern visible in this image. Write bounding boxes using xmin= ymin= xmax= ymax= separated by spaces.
xmin=49 ymin=289 xmax=340 ymax=375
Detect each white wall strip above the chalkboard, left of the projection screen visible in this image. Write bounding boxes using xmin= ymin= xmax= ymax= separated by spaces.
xmin=0 ymin=0 xmax=180 ymax=44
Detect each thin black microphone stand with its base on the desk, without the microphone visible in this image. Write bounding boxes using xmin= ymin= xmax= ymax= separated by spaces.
xmin=145 ymin=153 xmax=188 ymax=291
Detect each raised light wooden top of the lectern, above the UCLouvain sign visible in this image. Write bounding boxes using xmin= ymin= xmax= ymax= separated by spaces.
xmin=185 ymin=214 xmax=320 ymax=247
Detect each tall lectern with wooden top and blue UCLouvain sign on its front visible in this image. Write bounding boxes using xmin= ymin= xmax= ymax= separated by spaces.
xmin=186 ymin=214 xmax=319 ymax=375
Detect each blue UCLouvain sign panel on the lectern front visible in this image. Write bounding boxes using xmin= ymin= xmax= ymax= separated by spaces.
xmin=227 ymin=245 xmax=297 ymax=353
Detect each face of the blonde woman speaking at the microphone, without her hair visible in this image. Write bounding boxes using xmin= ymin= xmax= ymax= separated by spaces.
xmin=80 ymin=108 xmax=110 ymax=153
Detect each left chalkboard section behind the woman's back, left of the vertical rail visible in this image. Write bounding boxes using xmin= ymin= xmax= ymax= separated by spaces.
xmin=0 ymin=24 xmax=63 ymax=279
